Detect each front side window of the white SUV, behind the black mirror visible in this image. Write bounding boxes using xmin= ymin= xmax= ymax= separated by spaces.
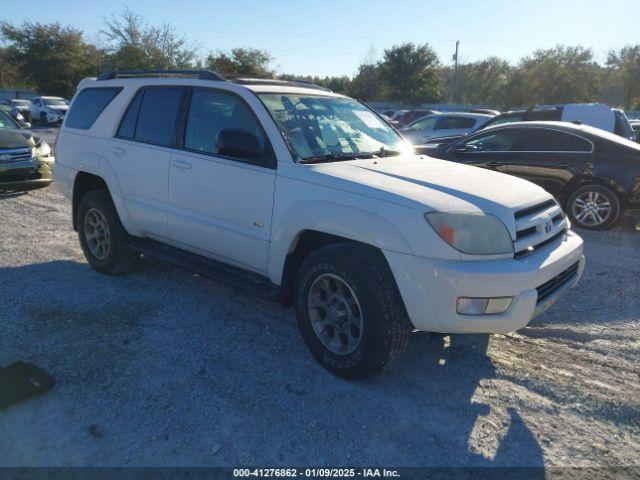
xmin=184 ymin=89 xmax=271 ymax=163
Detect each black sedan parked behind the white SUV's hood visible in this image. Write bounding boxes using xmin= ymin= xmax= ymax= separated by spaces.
xmin=420 ymin=122 xmax=640 ymax=230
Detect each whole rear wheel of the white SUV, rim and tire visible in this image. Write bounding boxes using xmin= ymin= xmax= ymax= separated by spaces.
xmin=76 ymin=190 xmax=138 ymax=275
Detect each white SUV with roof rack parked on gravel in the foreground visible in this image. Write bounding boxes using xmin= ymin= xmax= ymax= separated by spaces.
xmin=54 ymin=72 xmax=584 ymax=379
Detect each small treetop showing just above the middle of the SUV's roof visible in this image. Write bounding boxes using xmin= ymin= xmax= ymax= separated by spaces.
xmin=205 ymin=48 xmax=275 ymax=78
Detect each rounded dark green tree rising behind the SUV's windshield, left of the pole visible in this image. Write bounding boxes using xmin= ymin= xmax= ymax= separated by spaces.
xmin=378 ymin=43 xmax=441 ymax=104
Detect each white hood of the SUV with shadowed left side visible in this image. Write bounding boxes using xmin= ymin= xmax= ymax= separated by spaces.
xmin=310 ymin=155 xmax=552 ymax=225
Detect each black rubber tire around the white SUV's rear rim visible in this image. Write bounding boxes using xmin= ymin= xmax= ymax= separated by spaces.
xmin=76 ymin=190 xmax=139 ymax=275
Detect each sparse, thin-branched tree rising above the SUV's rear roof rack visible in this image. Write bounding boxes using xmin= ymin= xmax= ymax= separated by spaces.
xmin=101 ymin=8 xmax=197 ymax=70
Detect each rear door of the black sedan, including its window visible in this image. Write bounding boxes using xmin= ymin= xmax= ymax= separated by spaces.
xmin=506 ymin=127 xmax=593 ymax=195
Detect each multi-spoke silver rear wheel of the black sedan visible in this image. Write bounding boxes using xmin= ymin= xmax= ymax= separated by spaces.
xmin=567 ymin=185 xmax=620 ymax=230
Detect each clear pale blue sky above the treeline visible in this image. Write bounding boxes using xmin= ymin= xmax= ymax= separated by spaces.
xmin=5 ymin=0 xmax=640 ymax=75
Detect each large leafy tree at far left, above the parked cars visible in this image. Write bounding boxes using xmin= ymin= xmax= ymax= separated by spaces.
xmin=0 ymin=22 xmax=99 ymax=97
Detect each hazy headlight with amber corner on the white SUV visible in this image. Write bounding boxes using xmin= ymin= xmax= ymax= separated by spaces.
xmin=424 ymin=212 xmax=513 ymax=255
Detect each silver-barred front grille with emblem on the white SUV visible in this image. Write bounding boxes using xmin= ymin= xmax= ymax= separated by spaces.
xmin=514 ymin=199 xmax=567 ymax=258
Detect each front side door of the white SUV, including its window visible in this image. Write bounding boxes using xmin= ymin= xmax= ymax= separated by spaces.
xmin=169 ymin=88 xmax=276 ymax=272
